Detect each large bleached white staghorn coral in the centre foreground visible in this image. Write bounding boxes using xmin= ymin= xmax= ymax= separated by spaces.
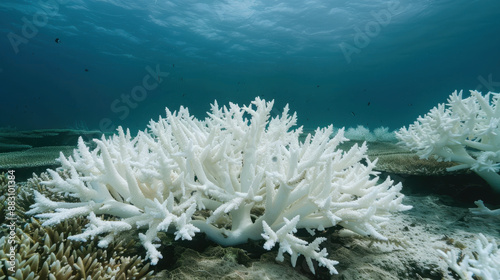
xmin=29 ymin=98 xmax=411 ymax=273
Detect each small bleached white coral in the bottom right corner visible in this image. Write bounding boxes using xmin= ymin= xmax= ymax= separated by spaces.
xmin=437 ymin=233 xmax=500 ymax=280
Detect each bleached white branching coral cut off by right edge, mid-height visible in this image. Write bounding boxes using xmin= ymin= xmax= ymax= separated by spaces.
xmin=396 ymin=90 xmax=500 ymax=192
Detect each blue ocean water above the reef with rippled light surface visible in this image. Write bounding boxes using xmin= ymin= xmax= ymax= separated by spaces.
xmin=0 ymin=0 xmax=500 ymax=131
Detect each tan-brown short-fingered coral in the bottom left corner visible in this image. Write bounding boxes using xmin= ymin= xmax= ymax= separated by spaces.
xmin=0 ymin=219 xmax=153 ymax=280
